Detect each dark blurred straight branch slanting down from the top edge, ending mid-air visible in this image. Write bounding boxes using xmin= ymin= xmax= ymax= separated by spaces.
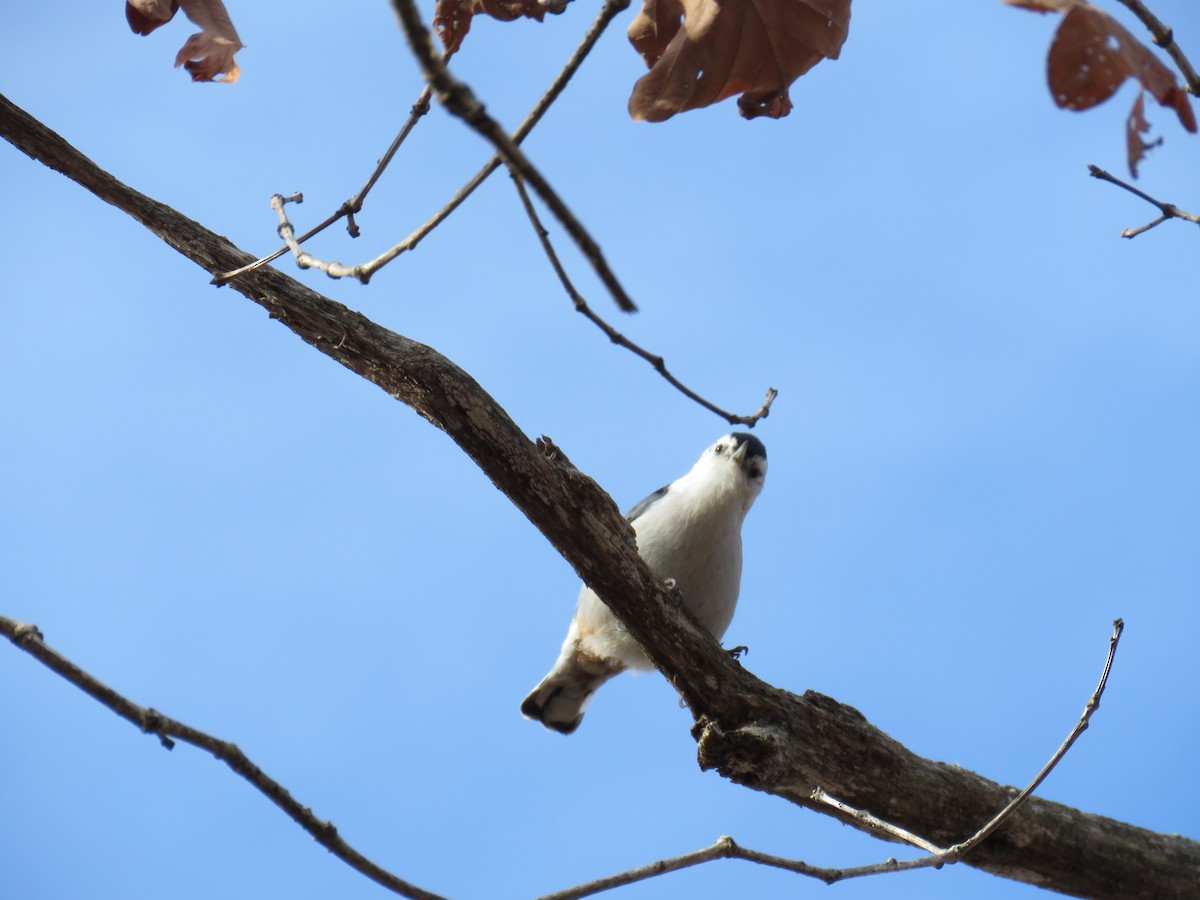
xmin=391 ymin=0 xmax=637 ymax=312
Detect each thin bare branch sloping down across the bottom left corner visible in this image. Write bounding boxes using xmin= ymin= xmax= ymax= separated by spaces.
xmin=0 ymin=616 xmax=443 ymax=900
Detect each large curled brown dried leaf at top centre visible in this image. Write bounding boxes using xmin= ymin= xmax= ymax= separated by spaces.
xmin=629 ymin=0 xmax=851 ymax=122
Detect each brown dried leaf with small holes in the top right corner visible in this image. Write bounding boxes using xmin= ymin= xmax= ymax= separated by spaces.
xmin=1007 ymin=0 xmax=1196 ymax=178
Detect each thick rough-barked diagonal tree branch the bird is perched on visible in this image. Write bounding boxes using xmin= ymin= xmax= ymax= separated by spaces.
xmin=0 ymin=97 xmax=1200 ymax=900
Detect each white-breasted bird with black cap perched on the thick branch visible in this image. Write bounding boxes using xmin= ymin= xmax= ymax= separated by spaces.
xmin=521 ymin=432 xmax=767 ymax=734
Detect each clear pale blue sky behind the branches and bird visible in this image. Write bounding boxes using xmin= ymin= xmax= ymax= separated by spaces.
xmin=0 ymin=0 xmax=1200 ymax=900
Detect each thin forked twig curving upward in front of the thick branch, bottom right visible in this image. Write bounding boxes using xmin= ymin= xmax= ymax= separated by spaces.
xmin=538 ymin=619 xmax=1124 ymax=900
